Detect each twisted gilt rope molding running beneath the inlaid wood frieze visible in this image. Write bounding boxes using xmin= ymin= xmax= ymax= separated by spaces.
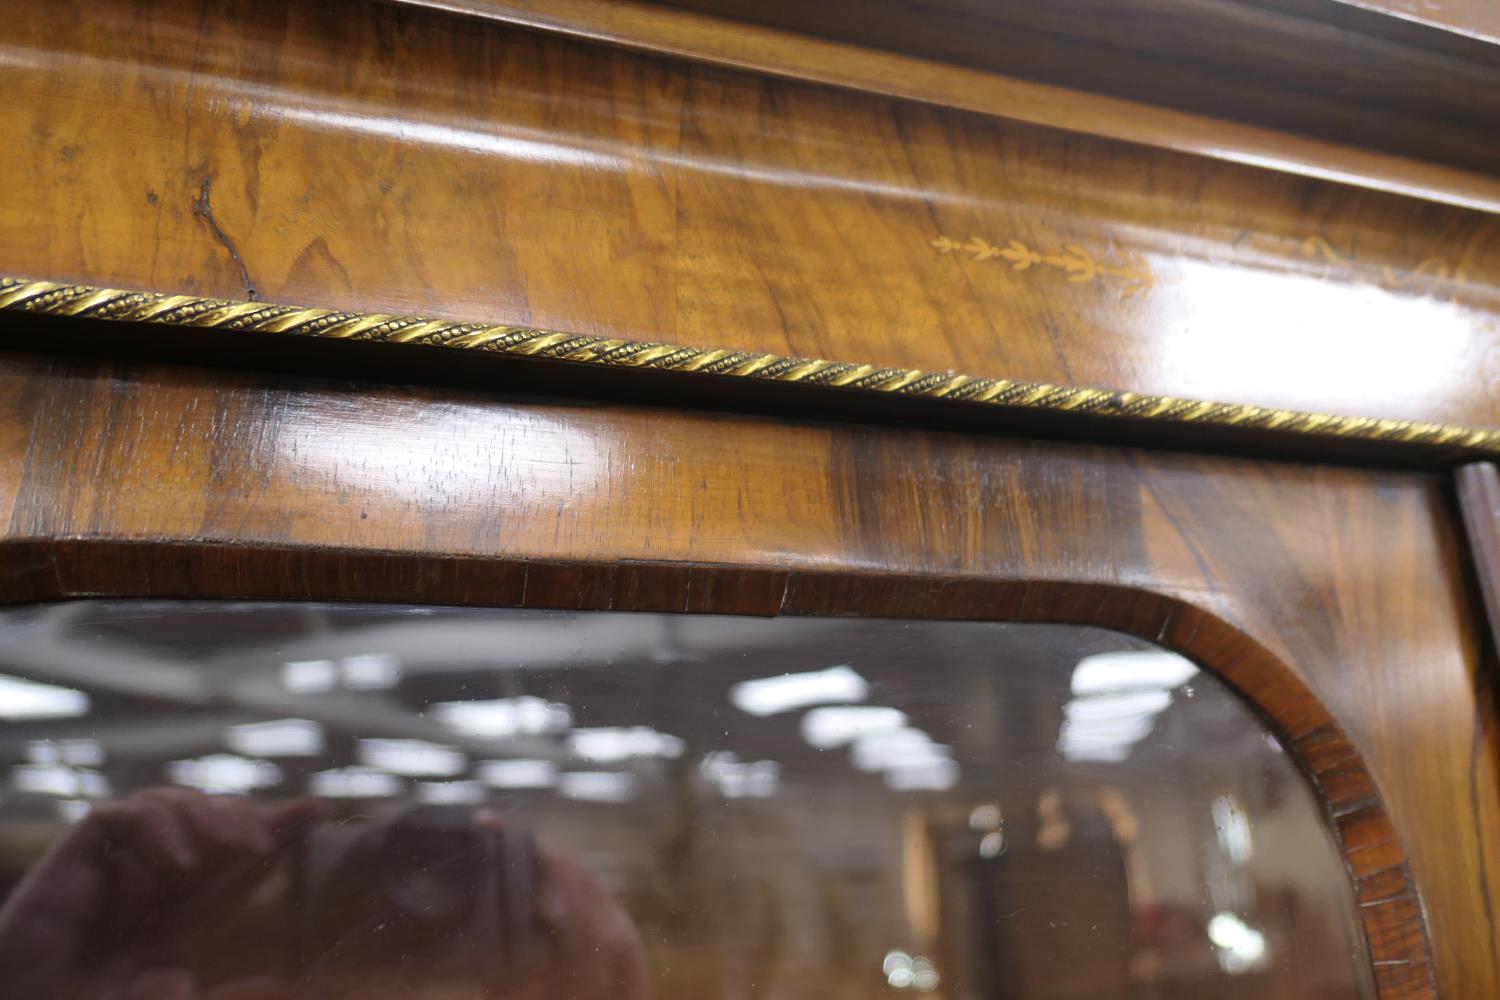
xmin=0 ymin=277 xmax=1500 ymax=456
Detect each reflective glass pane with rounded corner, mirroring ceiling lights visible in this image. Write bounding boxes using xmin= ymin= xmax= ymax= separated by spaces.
xmin=0 ymin=601 xmax=1373 ymax=1000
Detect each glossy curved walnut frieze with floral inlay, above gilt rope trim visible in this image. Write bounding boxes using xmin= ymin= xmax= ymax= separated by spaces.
xmin=0 ymin=0 xmax=1500 ymax=426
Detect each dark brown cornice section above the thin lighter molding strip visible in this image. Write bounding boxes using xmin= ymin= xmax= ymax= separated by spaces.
xmin=671 ymin=0 xmax=1500 ymax=172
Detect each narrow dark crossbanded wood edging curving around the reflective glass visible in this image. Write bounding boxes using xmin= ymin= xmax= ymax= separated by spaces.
xmin=0 ymin=538 xmax=1437 ymax=1000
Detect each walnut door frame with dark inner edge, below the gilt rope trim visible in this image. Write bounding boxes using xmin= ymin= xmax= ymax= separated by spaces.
xmin=0 ymin=355 xmax=1500 ymax=999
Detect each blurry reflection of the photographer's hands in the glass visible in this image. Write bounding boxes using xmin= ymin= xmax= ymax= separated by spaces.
xmin=0 ymin=789 xmax=644 ymax=1000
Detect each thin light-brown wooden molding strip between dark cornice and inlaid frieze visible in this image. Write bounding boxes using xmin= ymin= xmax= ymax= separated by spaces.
xmin=396 ymin=0 xmax=1500 ymax=213
